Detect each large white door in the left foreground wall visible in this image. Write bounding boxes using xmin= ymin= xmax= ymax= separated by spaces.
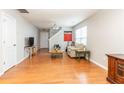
xmin=1 ymin=14 xmax=17 ymax=71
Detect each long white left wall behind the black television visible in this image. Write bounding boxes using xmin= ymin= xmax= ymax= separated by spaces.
xmin=0 ymin=10 xmax=40 ymax=62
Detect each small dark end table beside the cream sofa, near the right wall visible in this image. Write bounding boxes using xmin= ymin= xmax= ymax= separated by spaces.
xmin=76 ymin=49 xmax=90 ymax=60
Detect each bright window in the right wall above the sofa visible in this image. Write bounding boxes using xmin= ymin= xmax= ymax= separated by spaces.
xmin=75 ymin=26 xmax=87 ymax=45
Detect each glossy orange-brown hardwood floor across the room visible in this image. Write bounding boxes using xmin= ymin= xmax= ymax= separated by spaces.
xmin=0 ymin=49 xmax=109 ymax=84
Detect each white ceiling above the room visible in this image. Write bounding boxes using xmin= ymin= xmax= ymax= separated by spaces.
xmin=20 ymin=9 xmax=98 ymax=29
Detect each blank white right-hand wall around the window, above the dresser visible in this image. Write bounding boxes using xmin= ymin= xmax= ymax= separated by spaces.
xmin=74 ymin=10 xmax=124 ymax=68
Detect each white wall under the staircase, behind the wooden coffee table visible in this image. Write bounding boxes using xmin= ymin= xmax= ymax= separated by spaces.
xmin=49 ymin=28 xmax=72 ymax=50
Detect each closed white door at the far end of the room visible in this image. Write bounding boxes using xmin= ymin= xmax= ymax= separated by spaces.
xmin=40 ymin=31 xmax=48 ymax=48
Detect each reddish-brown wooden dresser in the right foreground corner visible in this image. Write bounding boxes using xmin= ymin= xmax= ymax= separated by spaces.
xmin=107 ymin=54 xmax=124 ymax=84
